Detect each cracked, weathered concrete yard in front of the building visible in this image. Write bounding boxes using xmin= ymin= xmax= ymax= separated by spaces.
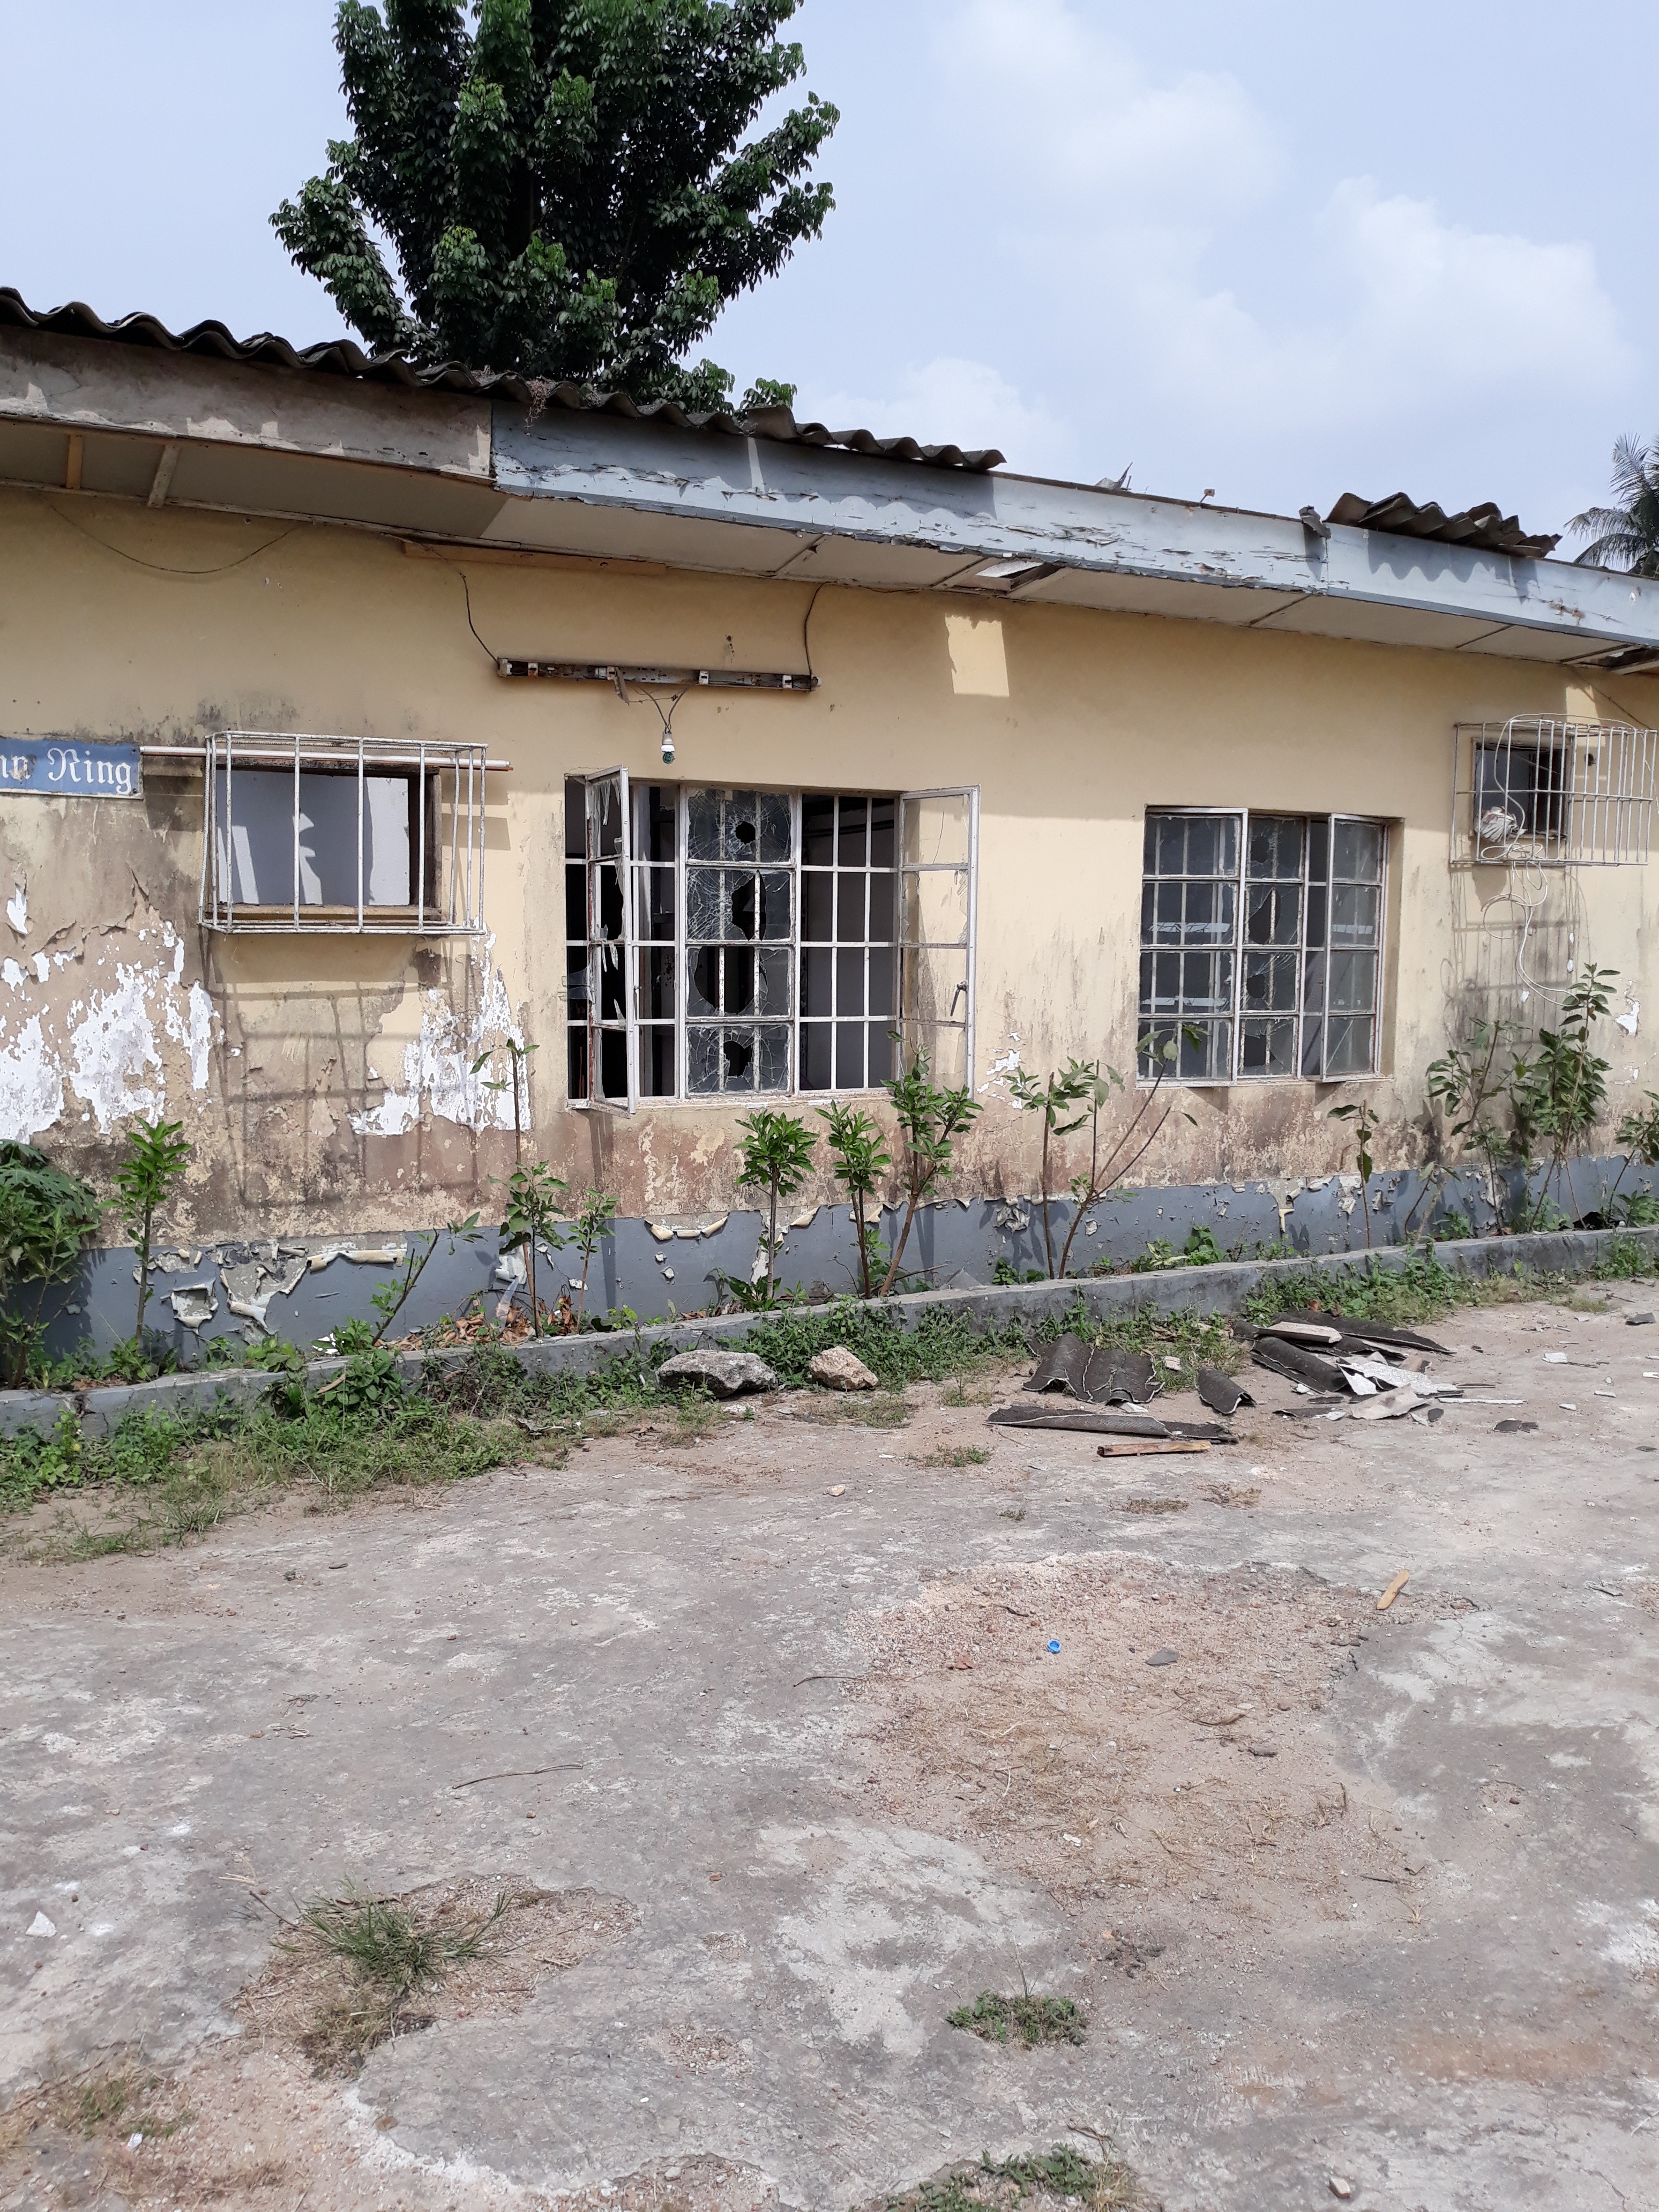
xmin=0 ymin=1285 xmax=1659 ymax=2212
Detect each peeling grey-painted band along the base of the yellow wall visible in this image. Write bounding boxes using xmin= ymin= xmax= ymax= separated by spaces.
xmin=19 ymin=1159 xmax=1655 ymax=1367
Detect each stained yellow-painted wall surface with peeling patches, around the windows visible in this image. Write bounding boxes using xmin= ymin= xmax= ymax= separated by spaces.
xmin=0 ymin=491 xmax=1659 ymax=1237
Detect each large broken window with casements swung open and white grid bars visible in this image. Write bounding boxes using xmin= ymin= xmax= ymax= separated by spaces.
xmin=564 ymin=787 xmax=978 ymax=1108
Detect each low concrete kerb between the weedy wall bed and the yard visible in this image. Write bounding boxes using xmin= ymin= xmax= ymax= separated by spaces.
xmin=0 ymin=1228 xmax=1659 ymax=1438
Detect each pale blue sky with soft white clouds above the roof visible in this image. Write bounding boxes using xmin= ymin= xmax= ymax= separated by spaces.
xmin=0 ymin=0 xmax=1659 ymax=531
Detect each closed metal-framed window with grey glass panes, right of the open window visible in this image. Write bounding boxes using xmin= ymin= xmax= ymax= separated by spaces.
xmin=1139 ymin=810 xmax=1387 ymax=1084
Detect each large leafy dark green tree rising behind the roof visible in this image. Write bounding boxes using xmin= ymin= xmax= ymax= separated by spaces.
xmin=272 ymin=0 xmax=841 ymax=409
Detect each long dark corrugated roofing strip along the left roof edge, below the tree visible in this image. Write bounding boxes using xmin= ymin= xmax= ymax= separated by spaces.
xmin=0 ymin=286 xmax=1004 ymax=473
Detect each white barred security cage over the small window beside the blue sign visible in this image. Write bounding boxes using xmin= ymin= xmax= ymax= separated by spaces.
xmin=160 ymin=730 xmax=509 ymax=938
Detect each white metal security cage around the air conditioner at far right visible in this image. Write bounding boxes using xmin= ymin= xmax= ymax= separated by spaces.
xmin=1451 ymin=714 xmax=1659 ymax=867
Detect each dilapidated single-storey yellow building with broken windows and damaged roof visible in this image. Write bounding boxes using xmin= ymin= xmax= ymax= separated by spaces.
xmin=0 ymin=292 xmax=1659 ymax=1334
